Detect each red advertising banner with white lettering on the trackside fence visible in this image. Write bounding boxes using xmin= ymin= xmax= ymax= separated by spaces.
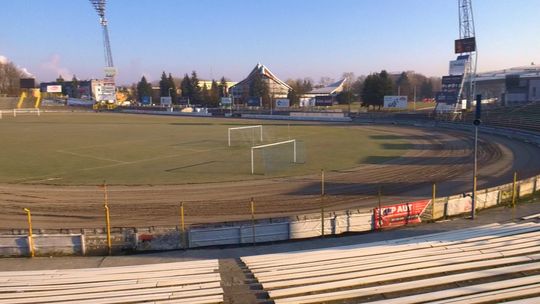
xmin=374 ymin=200 xmax=431 ymax=229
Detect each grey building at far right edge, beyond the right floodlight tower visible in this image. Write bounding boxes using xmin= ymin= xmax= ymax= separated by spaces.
xmin=474 ymin=65 xmax=540 ymax=105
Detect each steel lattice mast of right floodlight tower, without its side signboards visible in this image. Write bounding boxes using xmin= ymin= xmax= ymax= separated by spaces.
xmin=458 ymin=0 xmax=478 ymax=109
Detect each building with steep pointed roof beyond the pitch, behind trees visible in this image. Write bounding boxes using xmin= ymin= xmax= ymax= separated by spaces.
xmin=230 ymin=63 xmax=292 ymax=102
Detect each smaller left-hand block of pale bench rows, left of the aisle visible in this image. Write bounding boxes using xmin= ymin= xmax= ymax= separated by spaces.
xmin=0 ymin=260 xmax=223 ymax=304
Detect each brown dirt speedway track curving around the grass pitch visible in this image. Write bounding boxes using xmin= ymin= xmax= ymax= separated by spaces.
xmin=0 ymin=126 xmax=540 ymax=229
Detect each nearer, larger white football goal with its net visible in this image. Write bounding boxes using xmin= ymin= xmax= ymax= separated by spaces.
xmin=251 ymin=139 xmax=304 ymax=174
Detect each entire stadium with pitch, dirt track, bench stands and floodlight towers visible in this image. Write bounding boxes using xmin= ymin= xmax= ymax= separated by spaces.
xmin=0 ymin=0 xmax=540 ymax=304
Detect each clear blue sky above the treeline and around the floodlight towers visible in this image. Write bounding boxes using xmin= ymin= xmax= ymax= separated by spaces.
xmin=0 ymin=0 xmax=540 ymax=84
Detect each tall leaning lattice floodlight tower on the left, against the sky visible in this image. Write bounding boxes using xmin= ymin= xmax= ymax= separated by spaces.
xmin=90 ymin=0 xmax=116 ymax=104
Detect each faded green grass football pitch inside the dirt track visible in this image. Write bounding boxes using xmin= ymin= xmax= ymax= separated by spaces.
xmin=0 ymin=113 xmax=408 ymax=185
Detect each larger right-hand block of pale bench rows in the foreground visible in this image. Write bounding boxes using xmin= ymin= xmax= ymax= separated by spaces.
xmin=242 ymin=222 xmax=540 ymax=304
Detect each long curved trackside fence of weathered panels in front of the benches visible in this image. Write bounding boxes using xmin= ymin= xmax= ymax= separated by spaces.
xmin=0 ymin=176 xmax=540 ymax=256
